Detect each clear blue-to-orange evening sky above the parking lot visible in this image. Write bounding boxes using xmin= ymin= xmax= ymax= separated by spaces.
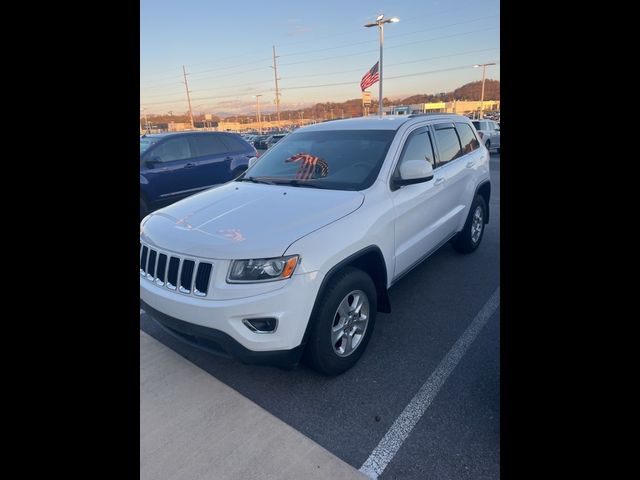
xmin=140 ymin=0 xmax=500 ymax=115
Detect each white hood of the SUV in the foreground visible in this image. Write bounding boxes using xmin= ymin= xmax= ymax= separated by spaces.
xmin=141 ymin=182 xmax=364 ymax=259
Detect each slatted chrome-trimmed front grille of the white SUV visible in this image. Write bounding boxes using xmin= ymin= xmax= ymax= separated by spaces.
xmin=140 ymin=242 xmax=213 ymax=297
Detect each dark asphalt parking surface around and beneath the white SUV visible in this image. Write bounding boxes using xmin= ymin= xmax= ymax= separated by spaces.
xmin=140 ymin=154 xmax=500 ymax=479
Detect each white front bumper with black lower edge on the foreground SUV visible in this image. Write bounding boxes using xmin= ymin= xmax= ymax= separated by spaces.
xmin=140 ymin=272 xmax=322 ymax=364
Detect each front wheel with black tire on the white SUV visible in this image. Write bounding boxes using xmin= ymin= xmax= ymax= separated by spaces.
xmin=304 ymin=267 xmax=378 ymax=376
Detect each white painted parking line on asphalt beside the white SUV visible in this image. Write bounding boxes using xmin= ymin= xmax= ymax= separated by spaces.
xmin=360 ymin=287 xmax=500 ymax=479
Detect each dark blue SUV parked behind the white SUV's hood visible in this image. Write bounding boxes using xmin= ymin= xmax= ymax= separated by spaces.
xmin=140 ymin=132 xmax=257 ymax=220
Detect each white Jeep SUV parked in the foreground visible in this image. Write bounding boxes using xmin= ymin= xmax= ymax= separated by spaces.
xmin=140 ymin=114 xmax=491 ymax=375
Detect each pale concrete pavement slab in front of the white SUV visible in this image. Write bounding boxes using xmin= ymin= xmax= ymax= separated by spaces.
xmin=140 ymin=331 xmax=366 ymax=480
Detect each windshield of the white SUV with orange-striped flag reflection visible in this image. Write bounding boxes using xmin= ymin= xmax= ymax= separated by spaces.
xmin=241 ymin=130 xmax=396 ymax=190
